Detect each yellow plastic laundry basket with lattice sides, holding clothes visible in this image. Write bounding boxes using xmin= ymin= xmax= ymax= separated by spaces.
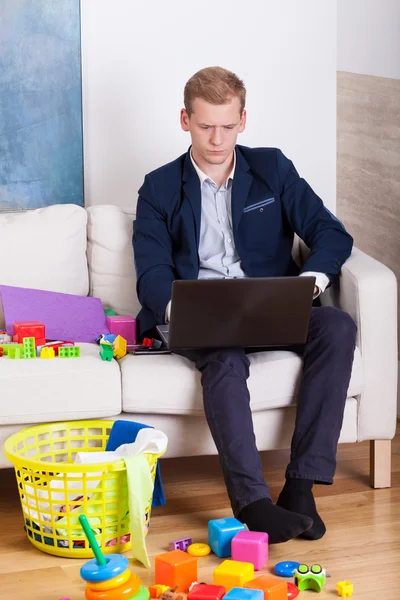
xmin=4 ymin=421 xmax=160 ymax=558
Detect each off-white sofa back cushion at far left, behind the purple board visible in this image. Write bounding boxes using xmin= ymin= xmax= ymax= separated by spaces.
xmin=0 ymin=204 xmax=89 ymax=328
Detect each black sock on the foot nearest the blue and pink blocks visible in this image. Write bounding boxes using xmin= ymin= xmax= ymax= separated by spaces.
xmin=237 ymin=498 xmax=312 ymax=544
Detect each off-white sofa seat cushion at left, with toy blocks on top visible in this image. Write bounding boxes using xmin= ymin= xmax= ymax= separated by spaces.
xmin=0 ymin=344 xmax=121 ymax=425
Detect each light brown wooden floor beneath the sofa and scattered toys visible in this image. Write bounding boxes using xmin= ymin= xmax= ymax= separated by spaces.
xmin=0 ymin=426 xmax=400 ymax=600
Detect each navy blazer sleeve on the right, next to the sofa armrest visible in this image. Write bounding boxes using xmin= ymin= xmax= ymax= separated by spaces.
xmin=277 ymin=150 xmax=353 ymax=279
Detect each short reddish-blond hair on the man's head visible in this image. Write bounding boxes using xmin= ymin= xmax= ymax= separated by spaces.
xmin=183 ymin=67 xmax=246 ymax=117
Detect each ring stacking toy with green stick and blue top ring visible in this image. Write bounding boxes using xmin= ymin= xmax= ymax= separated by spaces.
xmin=79 ymin=515 xmax=149 ymax=600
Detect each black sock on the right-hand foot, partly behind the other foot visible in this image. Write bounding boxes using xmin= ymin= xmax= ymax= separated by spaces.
xmin=277 ymin=477 xmax=326 ymax=540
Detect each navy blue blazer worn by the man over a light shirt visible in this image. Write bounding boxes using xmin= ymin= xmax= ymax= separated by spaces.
xmin=133 ymin=145 xmax=353 ymax=335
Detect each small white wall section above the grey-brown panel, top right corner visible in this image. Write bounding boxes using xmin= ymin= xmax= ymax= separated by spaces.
xmin=338 ymin=0 xmax=400 ymax=79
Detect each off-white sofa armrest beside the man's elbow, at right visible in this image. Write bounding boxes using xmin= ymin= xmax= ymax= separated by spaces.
xmin=321 ymin=248 xmax=398 ymax=441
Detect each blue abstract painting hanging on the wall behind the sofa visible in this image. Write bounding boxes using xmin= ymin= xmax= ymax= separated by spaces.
xmin=0 ymin=0 xmax=83 ymax=210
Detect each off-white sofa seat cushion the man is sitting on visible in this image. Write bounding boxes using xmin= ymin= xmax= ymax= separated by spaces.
xmin=120 ymin=349 xmax=363 ymax=415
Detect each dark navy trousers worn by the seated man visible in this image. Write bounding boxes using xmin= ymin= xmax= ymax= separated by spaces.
xmin=176 ymin=307 xmax=356 ymax=516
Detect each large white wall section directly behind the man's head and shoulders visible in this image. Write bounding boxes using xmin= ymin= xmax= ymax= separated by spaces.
xmin=82 ymin=0 xmax=336 ymax=211
